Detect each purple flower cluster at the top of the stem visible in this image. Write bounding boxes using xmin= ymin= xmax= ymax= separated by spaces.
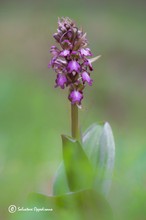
xmin=48 ymin=18 xmax=98 ymax=105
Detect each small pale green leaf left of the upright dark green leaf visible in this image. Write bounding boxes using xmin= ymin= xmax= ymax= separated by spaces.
xmin=53 ymin=161 xmax=70 ymax=195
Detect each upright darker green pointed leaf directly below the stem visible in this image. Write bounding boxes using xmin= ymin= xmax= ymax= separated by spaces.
xmin=62 ymin=135 xmax=94 ymax=191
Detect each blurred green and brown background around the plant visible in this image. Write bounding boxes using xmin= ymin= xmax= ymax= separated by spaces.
xmin=0 ymin=0 xmax=146 ymax=220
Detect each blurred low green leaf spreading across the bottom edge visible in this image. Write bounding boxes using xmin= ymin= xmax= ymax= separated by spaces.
xmin=13 ymin=190 xmax=112 ymax=220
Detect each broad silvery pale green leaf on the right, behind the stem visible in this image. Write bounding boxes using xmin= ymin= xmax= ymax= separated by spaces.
xmin=82 ymin=122 xmax=115 ymax=194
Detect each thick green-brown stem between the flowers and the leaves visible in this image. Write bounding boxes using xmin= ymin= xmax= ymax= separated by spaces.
xmin=71 ymin=104 xmax=79 ymax=139
